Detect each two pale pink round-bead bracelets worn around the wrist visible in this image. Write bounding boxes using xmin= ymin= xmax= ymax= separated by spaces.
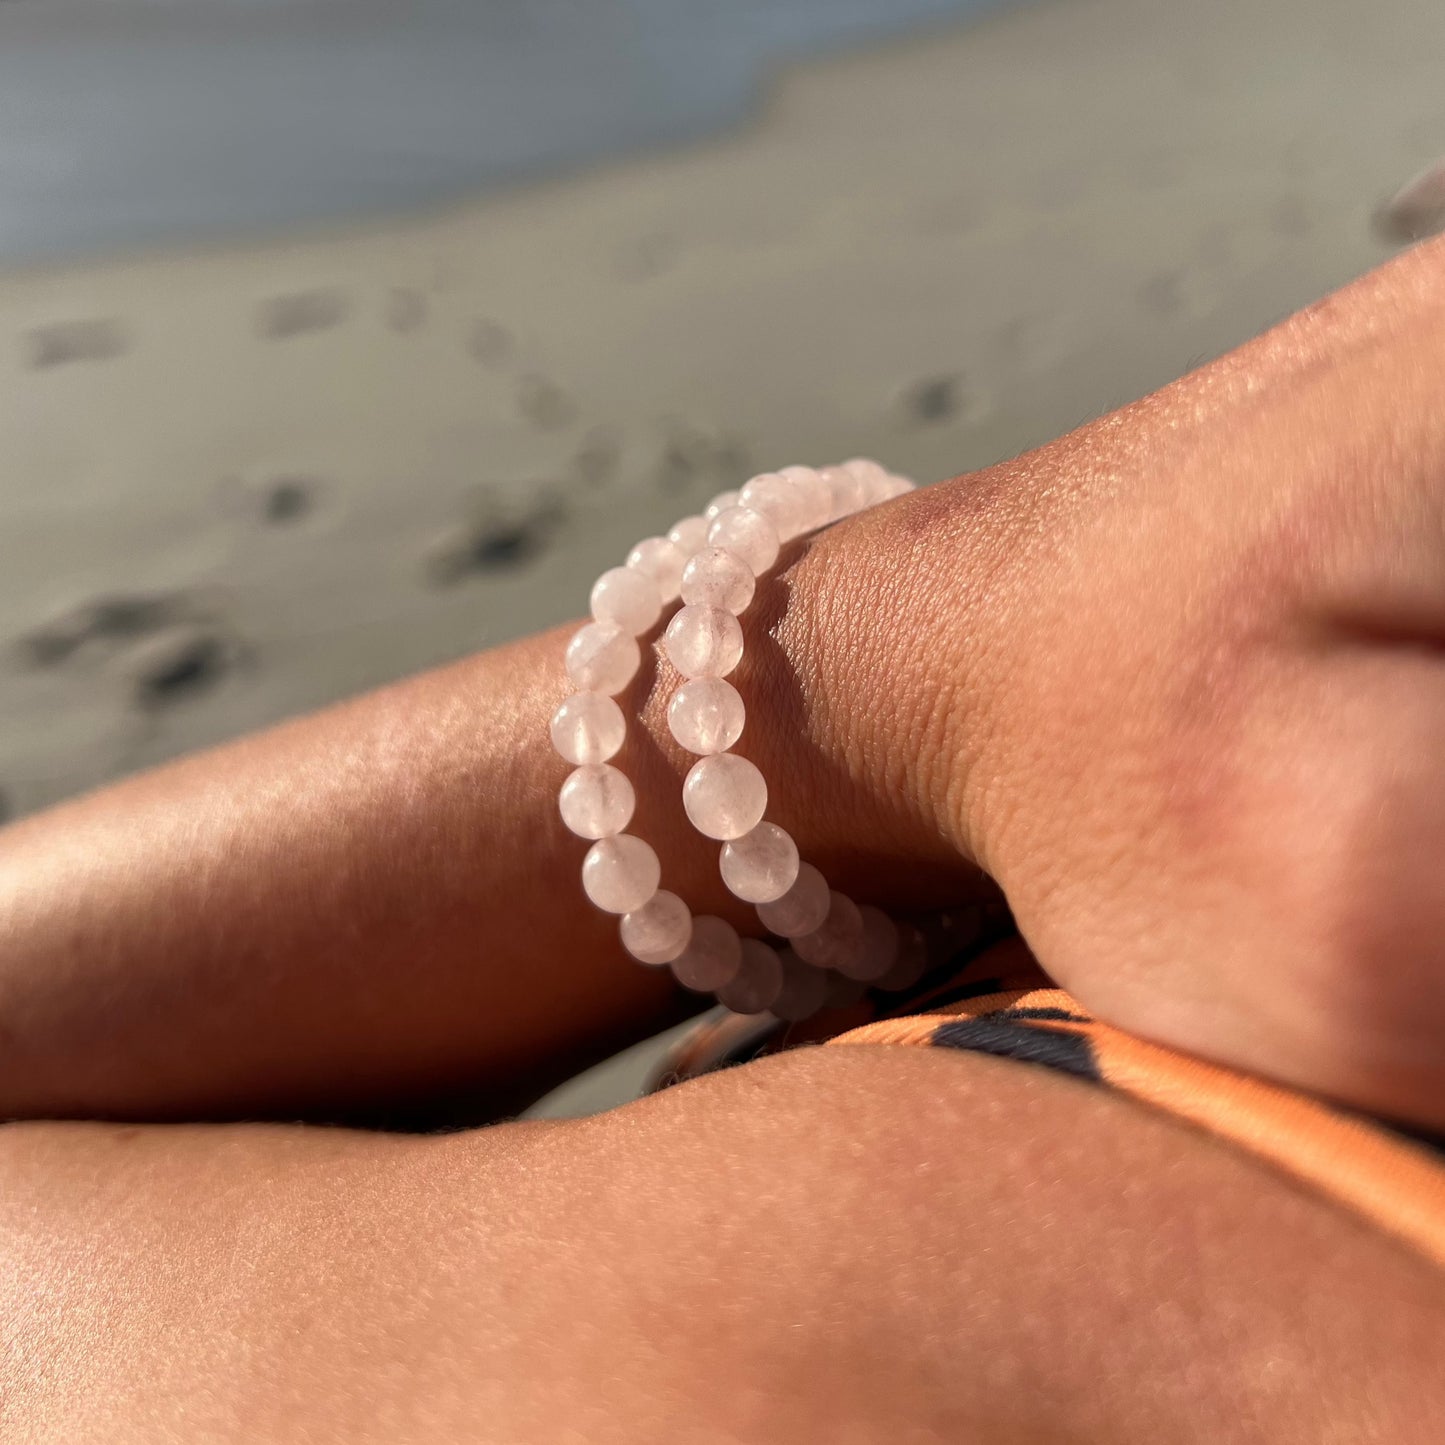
xmin=552 ymin=460 xmax=925 ymax=1020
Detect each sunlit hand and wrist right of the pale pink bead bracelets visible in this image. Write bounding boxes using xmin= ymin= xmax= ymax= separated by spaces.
xmin=783 ymin=234 xmax=1445 ymax=1127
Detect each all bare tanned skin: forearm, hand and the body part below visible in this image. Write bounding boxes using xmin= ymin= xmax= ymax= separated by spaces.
xmin=0 ymin=246 xmax=1445 ymax=1442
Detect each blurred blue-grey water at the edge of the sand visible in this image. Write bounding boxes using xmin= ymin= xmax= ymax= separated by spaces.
xmin=0 ymin=0 xmax=1019 ymax=262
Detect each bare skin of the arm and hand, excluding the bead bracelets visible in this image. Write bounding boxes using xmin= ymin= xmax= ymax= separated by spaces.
xmin=8 ymin=244 xmax=1445 ymax=1129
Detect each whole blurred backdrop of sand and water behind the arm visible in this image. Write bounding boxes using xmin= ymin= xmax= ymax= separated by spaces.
xmin=0 ymin=0 xmax=1445 ymax=815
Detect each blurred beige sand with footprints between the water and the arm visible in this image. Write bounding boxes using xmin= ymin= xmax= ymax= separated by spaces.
xmin=0 ymin=0 xmax=1445 ymax=812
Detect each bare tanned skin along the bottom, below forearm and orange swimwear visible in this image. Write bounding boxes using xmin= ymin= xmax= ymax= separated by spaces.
xmin=0 ymin=1048 xmax=1445 ymax=1445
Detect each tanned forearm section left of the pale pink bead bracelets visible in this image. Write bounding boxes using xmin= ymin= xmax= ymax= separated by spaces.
xmin=0 ymin=637 xmax=684 ymax=1116
